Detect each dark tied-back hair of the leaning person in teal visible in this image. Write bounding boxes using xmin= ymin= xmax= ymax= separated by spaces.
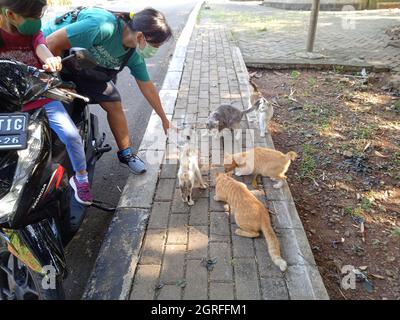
xmin=114 ymin=7 xmax=172 ymax=44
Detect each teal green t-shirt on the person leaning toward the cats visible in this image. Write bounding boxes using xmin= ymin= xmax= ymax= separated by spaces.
xmin=42 ymin=8 xmax=150 ymax=81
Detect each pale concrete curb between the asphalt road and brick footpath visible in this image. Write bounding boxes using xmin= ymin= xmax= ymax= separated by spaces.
xmin=82 ymin=1 xmax=204 ymax=300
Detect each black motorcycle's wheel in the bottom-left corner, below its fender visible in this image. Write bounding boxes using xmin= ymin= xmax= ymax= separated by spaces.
xmin=0 ymin=239 xmax=65 ymax=301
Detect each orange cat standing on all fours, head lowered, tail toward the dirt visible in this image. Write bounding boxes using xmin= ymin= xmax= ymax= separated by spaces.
xmin=224 ymin=147 xmax=297 ymax=188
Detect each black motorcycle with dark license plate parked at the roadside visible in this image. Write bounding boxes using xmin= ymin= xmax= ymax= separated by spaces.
xmin=0 ymin=48 xmax=115 ymax=300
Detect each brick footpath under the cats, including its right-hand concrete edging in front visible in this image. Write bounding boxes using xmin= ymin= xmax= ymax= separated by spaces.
xmin=130 ymin=18 xmax=328 ymax=300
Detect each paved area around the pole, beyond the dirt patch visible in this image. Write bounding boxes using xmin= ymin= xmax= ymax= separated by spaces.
xmin=202 ymin=0 xmax=400 ymax=72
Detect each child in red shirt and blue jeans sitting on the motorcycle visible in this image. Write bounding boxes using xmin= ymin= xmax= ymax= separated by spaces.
xmin=0 ymin=0 xmax=93 ymax=205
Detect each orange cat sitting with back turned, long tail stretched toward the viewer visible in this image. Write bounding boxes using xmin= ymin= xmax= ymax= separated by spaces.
xmin=214 ymin=172 xmax=287 ymax=271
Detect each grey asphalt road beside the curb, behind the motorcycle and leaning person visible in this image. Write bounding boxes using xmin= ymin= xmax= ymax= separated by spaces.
xmin=57 ymin=0 xmax=197 ymax=299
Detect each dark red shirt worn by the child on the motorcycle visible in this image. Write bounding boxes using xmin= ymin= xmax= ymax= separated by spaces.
xmin=0 ymin=28 xmax=52 ymax=111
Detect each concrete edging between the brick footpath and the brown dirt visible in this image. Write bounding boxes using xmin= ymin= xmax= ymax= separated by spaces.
xmin=234 ymin=47 xmax=329 ymax=300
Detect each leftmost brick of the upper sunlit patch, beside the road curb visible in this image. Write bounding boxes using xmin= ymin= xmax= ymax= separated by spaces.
xmin=139 ymin=229 xmax=166 ymax=264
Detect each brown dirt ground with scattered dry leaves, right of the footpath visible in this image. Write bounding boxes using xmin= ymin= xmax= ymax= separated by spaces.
xmin=249 ymin=69 xmax=400 ymax=300
